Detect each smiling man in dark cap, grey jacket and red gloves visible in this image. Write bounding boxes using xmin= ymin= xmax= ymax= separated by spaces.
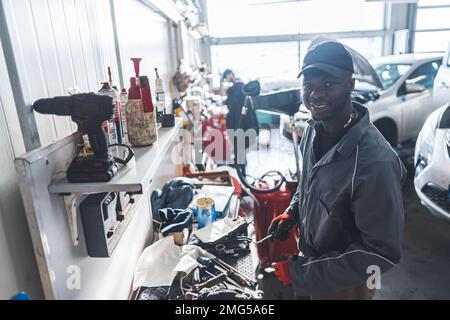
xmin=269 ymin=41 xmax=406 ymax=299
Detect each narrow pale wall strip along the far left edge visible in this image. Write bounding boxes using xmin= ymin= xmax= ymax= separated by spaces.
xmin=0 ymin=23 xmax=43 ymax=299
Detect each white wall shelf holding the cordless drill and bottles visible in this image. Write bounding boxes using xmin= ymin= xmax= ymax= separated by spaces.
xmin=48 ymin=118 xmax=182 ymax=195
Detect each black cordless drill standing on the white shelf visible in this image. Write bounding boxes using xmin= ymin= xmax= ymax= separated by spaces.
xmin=33 ymin=93 xmax=117 ymax=182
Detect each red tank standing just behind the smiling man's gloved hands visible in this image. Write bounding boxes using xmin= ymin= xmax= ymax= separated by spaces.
xmin=253 ymin=182 xmax=299 ymax=268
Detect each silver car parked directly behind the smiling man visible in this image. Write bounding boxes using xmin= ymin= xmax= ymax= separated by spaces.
xmin=281 ymin=54 xmax=442 ymax=146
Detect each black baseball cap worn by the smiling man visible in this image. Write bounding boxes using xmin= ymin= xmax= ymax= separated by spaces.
xmin=297 ymin=41 xmax=355 ymax=78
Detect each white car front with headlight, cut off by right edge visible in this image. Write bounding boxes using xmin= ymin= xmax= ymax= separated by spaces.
xmin=414 ymin=103 xmax=450 ymax=222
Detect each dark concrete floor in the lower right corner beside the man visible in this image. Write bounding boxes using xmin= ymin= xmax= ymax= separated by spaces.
xmin=374 ymin=172 xmax=450 ymax=299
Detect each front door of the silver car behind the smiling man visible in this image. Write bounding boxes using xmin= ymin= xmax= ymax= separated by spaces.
xmin=397 ymin=60 xmax=441 ymax=140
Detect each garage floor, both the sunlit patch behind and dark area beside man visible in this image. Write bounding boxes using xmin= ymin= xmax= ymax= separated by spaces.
xmin=247 ymin=128 xmax=450 ymax=299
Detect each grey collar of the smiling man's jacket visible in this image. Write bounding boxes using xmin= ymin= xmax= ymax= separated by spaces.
xmin=308 ymin=101 xmax=370 ymax=158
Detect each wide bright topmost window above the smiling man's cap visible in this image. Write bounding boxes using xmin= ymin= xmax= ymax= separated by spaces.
xmin=207 ymin=0 xmax=384 ymax=37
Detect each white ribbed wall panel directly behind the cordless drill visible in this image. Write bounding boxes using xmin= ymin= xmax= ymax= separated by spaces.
xmin=3 ymin=0 xmax=118 ymax=145
